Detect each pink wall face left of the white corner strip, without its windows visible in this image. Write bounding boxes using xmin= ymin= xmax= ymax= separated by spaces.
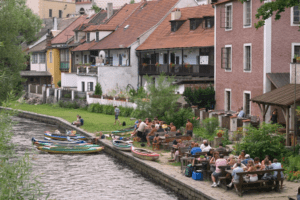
xmin=215 ymin=1 xmax=264 ymax=115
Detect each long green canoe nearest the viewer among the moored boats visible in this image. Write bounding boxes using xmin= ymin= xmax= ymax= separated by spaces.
xmin=37 ymin=146 xmax=104 ymax=154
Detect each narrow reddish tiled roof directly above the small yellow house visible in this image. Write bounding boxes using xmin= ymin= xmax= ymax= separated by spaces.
xmin=51 ymin=14 xmax=95 ymax=44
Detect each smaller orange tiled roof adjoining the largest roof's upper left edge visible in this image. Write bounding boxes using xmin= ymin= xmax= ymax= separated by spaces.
xmin=84 ymin=3 xmax=140 ymax=31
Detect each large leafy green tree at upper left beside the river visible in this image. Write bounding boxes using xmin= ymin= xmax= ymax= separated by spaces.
xmin=0 ymin=0 xmax=42 ymax=104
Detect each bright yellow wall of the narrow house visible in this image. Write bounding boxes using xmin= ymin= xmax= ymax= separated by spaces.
xmin=47 ymin=49 xmax=61 ymax=87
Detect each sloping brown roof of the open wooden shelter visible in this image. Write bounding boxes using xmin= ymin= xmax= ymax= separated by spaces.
xmin=251 ymin=84 xmax=300 ymax=106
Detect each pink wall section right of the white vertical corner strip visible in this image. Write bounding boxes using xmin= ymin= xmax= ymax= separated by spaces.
xmin=271 ymin=8 xmax=300 ymax=73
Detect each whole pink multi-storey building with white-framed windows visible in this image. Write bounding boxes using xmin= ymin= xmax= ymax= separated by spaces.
xmin=214 ymin=0 xmax=300 ymax=121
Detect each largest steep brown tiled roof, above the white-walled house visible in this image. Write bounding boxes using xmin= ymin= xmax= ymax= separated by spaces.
xmin=90 ymin=0 xmax=178 ymax=50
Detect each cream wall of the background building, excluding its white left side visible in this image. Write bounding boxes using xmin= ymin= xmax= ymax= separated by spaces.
xmin=39 ymin=0 xmax=75 ymax=19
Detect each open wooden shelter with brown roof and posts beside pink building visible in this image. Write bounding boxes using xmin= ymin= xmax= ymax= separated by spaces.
xmin=250 ymin=84 xmax=300 ymax=146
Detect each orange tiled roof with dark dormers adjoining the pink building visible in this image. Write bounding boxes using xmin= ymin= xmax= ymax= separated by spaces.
xmin=137 ymin=5 xmax=214 ymax=50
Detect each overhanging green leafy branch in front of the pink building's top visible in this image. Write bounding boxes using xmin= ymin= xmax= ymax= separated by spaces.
xmin=239 ymin=0 xmax=299 ymax=28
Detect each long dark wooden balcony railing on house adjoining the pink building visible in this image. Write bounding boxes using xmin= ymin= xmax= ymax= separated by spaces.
xmin=139 ymin=64 xmax=214 ymax=77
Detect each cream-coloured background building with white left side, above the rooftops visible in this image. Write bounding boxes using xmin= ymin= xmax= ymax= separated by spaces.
xmin=26 ymin=0 xmax=76 ymax=19
